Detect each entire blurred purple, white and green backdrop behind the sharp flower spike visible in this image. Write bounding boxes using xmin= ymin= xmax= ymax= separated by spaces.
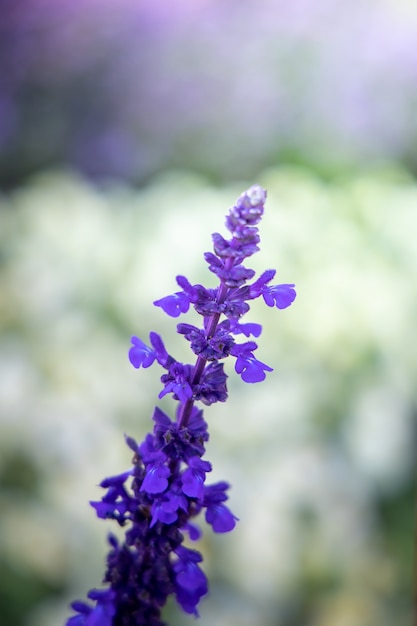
xmin=0 ymin=0 xmax=417 ymax=626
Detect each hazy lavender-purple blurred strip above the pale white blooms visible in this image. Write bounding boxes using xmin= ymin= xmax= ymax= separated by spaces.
xmin=0 ymin=0 xmax=417 ymax=188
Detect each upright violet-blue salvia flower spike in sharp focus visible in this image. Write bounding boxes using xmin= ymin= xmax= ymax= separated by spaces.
xmin=67 ymin=185 xmax=296 ymax=626
